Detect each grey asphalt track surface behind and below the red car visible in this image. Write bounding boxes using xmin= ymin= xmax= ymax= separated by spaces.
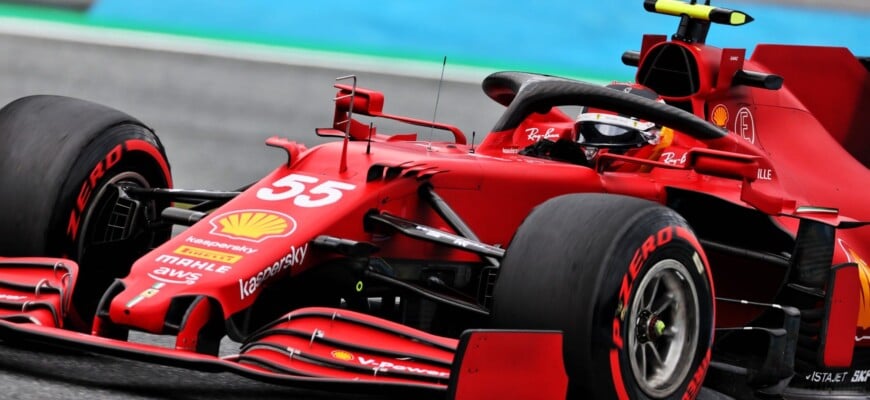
xmin=0 ymin=35 xmax=510 ymax=400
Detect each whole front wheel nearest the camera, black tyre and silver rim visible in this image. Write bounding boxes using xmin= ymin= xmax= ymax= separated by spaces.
xmin=492 ymin=194 xmax=714 ymax=399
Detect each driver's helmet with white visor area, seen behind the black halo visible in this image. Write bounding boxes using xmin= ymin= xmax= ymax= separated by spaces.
xmin=574 ymin=82 xmax=664 ymax=149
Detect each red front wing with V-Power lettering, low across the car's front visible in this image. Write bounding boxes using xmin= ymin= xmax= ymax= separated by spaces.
xmin=0 ymin=258 xmax=568 ymax=399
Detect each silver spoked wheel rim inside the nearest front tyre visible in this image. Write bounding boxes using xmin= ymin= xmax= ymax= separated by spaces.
xmin=628 ymin=259 xmax=700 ymax=398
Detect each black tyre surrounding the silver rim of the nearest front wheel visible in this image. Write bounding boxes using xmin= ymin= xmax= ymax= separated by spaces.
xmin=491 ymin=193 xmax=714 ymax=399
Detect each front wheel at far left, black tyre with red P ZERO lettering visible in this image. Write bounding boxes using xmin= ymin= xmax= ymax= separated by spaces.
xmin=0 ymin=96 xmax=172 ymax=329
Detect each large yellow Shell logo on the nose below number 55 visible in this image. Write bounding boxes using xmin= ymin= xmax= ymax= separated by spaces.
xmin=209 ymin=210 xmax=296 ymax=243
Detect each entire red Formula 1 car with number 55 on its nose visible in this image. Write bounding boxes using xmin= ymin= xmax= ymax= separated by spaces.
xmin=0 ymin=0 xmax=870 ymax=399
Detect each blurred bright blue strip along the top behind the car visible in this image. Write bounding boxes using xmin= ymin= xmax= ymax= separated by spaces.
xmin=89 ymin=0 xmax=870 ymax=79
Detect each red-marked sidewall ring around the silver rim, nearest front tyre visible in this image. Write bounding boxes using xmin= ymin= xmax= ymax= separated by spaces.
xmin=584 ymin=208 xmax=714 ymax=399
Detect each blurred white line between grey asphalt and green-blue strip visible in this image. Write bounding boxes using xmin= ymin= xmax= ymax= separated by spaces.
xmin=0 ymin=17 xmax=504 ymax=84
